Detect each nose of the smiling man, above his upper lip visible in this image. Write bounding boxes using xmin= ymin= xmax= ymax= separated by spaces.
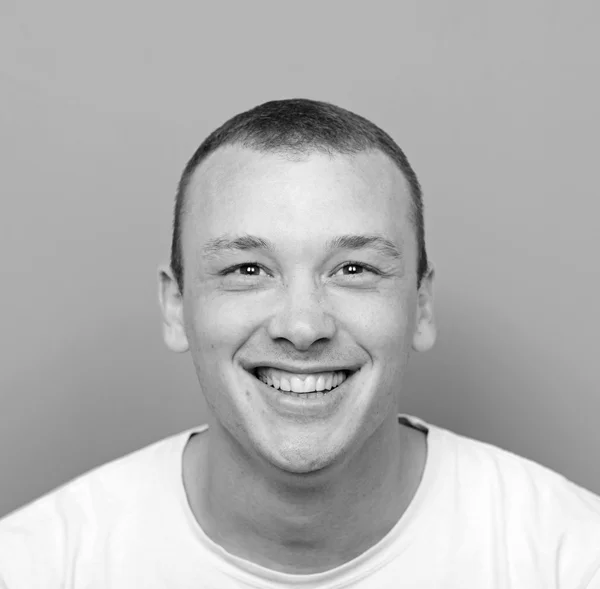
xmin=267 ymin=279 xmax=336 ymax=350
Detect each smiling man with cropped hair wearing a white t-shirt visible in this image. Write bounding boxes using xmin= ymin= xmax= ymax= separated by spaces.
xmin=0 ymin=100 xmax=600 ymax=589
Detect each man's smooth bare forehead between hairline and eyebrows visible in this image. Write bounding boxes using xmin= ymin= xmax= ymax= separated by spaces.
xmin=184 ymin=146 xmax=410 ymax=249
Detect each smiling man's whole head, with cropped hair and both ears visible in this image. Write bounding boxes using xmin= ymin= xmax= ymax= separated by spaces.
xmin=159 ymin=100 xmax=435 ymax=473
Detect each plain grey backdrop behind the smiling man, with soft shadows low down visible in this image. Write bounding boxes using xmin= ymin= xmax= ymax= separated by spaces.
xmin=0 ymin=0 xmax=600 ymax=515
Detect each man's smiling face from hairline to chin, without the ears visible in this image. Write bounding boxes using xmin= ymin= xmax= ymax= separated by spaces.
xmin=169 ymin=147 xmax=432 ymax=473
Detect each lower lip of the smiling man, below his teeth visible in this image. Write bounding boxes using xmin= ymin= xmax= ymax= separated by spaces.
xmin=250 ymin=370 xmax=359 ymax=418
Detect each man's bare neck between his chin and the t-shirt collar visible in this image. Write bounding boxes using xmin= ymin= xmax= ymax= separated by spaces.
xmin=184 ymin=415 xmax=426 ymax=574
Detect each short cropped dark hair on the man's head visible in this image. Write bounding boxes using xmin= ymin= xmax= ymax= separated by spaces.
xmin=171 ymin=98 xmax=428 ymax=295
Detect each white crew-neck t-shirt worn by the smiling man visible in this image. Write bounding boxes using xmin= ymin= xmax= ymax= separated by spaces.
xmin=0 ymin=414 xmax=600 ymax=589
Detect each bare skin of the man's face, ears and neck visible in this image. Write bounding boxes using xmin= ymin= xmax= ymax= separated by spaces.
xmin=159 ymin=146 xmax=436 ymax=574
